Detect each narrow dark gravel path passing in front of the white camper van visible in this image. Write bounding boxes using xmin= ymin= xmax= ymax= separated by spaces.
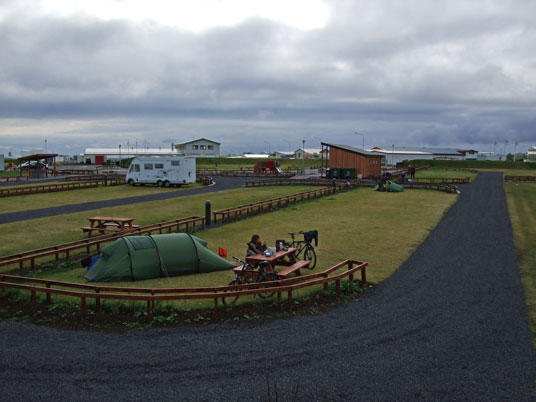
xmin=0 ymin=177 xmax=250 ymax=224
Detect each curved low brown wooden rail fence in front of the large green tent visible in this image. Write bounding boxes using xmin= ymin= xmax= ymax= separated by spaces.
xmin=0 ymin=259 xmax=368 ymax=322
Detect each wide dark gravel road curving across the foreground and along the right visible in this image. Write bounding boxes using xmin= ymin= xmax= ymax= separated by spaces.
xmin=0 ymin=173 xmax=536 ymax=401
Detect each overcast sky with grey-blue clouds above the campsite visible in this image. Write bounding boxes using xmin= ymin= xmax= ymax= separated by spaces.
xmin=0 ymin=0 xmax=536 ymax=156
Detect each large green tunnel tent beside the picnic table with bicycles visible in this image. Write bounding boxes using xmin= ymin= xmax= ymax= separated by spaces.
xmin=84 ymin=233 xmax=234 ymax=282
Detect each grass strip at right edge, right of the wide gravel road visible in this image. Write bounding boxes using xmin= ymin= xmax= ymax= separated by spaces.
xmin=504 ymin=183 xmax=536 ymax=340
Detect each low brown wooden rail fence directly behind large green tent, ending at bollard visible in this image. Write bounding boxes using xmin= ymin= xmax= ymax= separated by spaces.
xmin=0 ymin=216 xmax=205 ymax=269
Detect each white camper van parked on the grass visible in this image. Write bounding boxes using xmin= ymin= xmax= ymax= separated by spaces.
xmin=126 ymin=156 xmax=195 ymax=187
